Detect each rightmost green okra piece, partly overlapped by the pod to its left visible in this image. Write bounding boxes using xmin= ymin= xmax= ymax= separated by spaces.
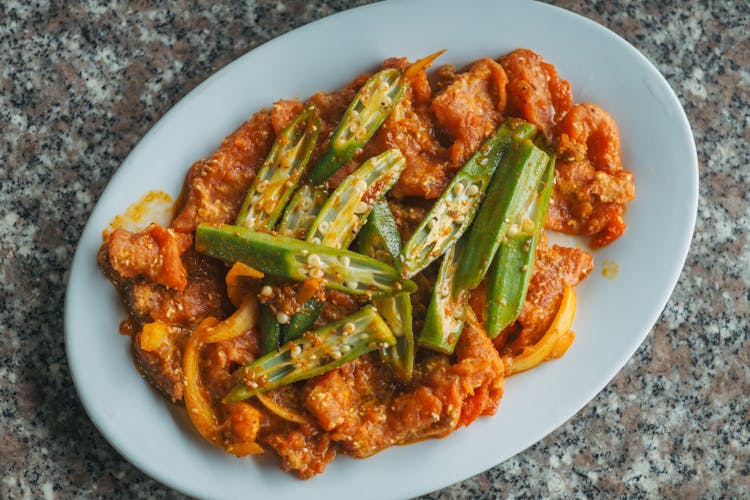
xmin=484 ymin=156 xmax=555 ymax=338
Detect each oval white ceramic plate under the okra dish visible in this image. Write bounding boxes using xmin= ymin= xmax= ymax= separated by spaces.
xmin=65 ymin=0 xmax=698 ymax=500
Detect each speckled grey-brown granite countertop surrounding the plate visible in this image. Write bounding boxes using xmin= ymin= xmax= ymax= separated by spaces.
xmin=0 ymin=0 xmax=750 ymax=498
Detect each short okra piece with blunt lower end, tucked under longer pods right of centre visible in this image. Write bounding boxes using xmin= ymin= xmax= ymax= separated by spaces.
xmin=417 ymin=238 xmax=469 ymax=354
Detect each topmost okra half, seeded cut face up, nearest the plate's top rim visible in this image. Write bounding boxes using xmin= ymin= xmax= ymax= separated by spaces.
xmin=311 ymin=68 xmax=404 ymax=185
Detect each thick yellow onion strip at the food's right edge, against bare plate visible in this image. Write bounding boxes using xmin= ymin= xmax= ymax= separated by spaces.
xmin=508 ymin=285 xmax=576 ymax=375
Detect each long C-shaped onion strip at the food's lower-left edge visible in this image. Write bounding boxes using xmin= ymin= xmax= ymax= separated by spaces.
xmin=182 ymin=317 xmax=263 ymax=456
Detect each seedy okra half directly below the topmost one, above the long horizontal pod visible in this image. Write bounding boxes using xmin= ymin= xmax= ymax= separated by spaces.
xmin=307 ymin=149 xmax=406 ymax=248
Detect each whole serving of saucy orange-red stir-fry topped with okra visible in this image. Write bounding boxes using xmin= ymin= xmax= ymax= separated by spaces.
xmin=98 ymin=49 xmax=635 ymax=478
